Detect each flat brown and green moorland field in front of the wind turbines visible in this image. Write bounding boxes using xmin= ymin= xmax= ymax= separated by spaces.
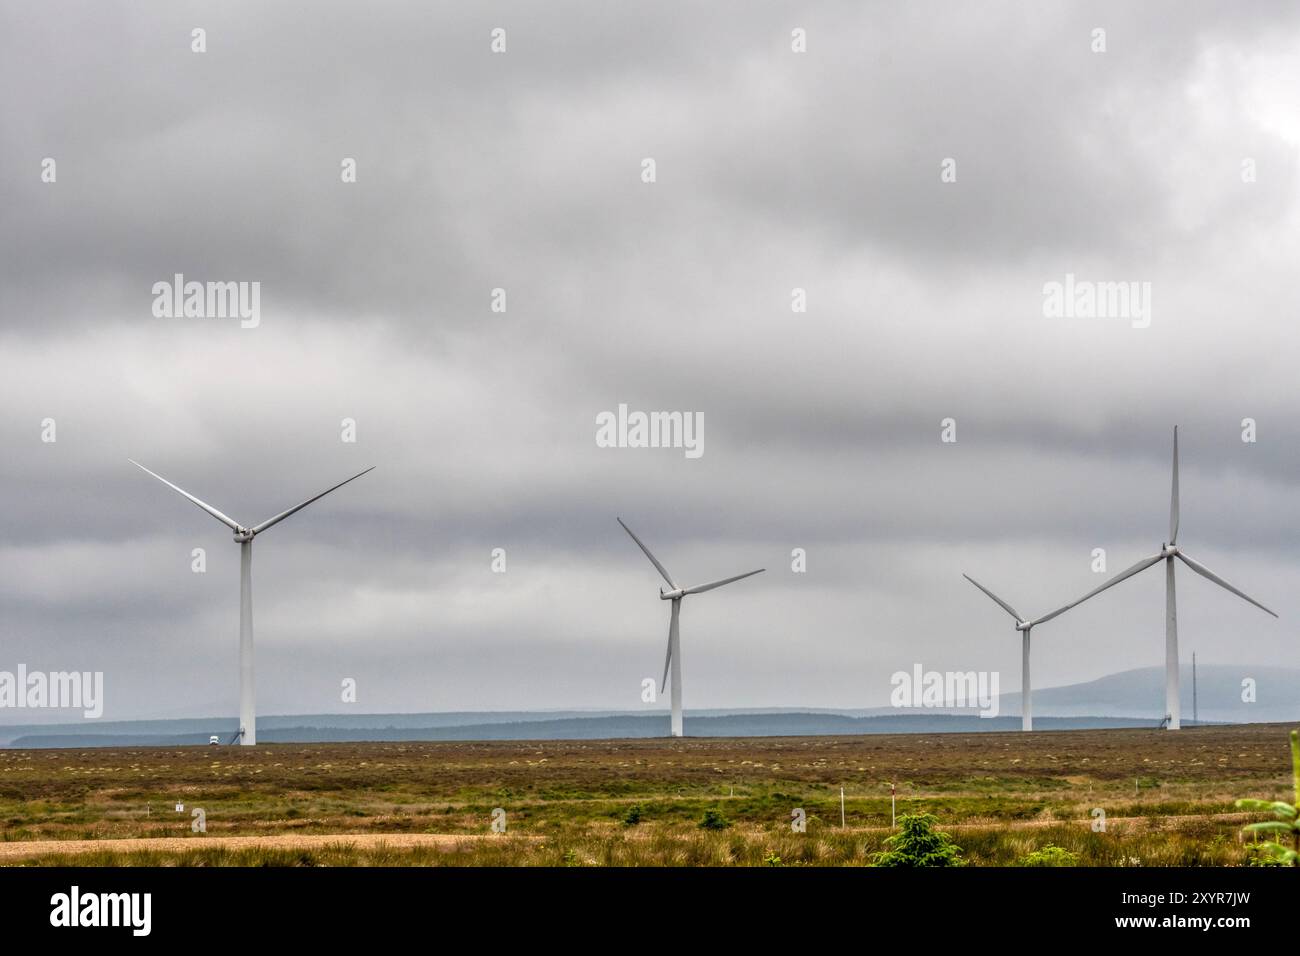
xmin=0 ymin=724 xmax=1292 ymax=866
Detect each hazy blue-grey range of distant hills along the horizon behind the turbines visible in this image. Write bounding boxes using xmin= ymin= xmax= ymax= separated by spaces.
xmin=0 ymin=665 xmax=1300 ymax=748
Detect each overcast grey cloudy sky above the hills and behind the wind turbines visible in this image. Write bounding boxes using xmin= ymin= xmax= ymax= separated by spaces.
xmin=0 ymin=0 xmax=1300 ymax=723
